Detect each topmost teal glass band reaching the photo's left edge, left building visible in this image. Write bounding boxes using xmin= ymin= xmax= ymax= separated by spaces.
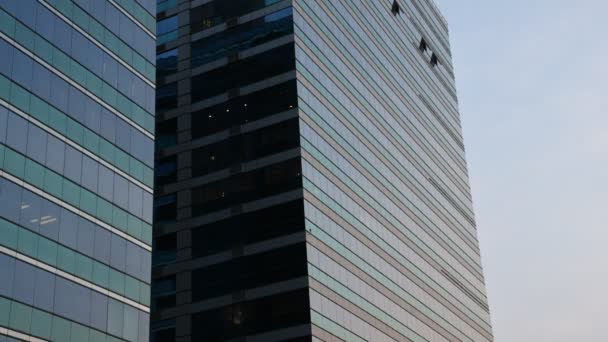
xmin=0 ymin=6 xmax=154 ymax=113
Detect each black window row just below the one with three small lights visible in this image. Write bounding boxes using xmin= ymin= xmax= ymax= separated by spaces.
xmin=192 ymin=118 xmax=300 ymax=177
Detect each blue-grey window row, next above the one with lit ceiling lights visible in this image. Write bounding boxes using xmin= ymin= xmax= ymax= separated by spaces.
xmin=0 ymin=110 xmax=152 ymax=222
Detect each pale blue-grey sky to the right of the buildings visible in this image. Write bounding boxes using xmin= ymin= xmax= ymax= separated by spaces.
xmin=435 ymin=0 xmax=608 ymax=342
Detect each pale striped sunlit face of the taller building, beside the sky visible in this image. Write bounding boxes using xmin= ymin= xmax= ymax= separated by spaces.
xmin=294 ymin=0 xmax=492 ymax=341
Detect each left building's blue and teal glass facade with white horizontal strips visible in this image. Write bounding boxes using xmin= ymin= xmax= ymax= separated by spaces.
xmin=0 ymin=0 xmax=156 ymax=342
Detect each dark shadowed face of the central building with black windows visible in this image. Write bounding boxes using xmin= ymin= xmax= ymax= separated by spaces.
xmin=151 ymin=0 xmax=310 ymax=341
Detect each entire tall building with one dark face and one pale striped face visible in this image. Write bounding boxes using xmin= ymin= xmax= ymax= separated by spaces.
xmin=151 ymin=0 xmax=493 ymax=342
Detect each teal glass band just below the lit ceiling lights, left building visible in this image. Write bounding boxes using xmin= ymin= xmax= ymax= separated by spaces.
xmin=0 ymin=216 xmax=150 ymax=306
